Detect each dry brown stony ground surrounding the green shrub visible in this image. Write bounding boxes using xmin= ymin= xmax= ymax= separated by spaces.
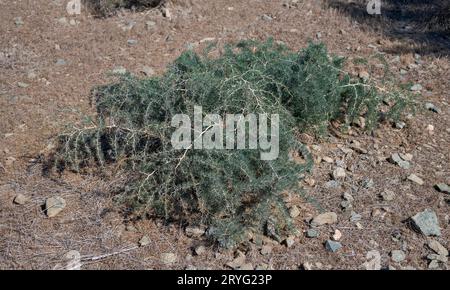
xmin=0 ymin=0 xmax=450 ymax=269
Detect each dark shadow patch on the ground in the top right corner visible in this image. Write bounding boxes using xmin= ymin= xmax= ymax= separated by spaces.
xmin=324 ymin=0 xmax=450 ymax=56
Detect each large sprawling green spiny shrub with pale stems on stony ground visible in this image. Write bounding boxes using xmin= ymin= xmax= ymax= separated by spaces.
xmin=57 ymin=40 xmax=405 ymax=247
